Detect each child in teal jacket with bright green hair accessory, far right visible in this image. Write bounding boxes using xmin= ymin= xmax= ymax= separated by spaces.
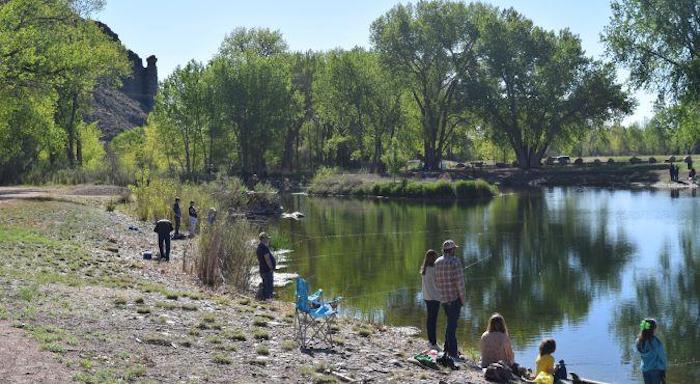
xmin=635 ymin=319 xmax=667 ymax=384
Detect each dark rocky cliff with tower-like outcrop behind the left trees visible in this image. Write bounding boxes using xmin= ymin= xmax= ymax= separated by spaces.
xmin=86 ymin=21 xmax=158 ymax=141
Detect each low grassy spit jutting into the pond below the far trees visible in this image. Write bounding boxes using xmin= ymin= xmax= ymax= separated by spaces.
xmin=309 ymin=172 xmax=498 ymax=200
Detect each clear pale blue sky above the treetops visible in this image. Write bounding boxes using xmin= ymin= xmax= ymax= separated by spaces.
xmin=96 ymin=0 xmax=653 ymax=121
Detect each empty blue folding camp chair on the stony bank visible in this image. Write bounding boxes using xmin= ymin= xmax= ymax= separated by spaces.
xmin=295 ymin=277 xmax=342 ymax=349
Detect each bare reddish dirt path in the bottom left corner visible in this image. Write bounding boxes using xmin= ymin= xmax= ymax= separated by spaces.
xmin=0 ymin=321 xmax=73 ymax=384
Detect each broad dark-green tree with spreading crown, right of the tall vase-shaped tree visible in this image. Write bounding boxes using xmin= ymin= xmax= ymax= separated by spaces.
xmin=463 ymin=6 xmax=632 ymax=169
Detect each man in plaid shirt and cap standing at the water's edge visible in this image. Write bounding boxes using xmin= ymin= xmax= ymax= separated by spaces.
xmin=435 ymin=240 xmax=466 ymax=361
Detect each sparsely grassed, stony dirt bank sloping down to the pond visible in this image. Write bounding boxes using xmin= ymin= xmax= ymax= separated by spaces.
xmin=0 ymin=189 xmax=486 ymax=383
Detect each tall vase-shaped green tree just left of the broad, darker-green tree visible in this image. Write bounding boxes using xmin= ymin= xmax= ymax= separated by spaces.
xmin=371 ymin=1 xmax=477 ymax=170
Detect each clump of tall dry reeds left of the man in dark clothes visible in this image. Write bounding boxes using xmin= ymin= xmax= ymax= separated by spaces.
xmin=195 ymin=220 xmax=255 ymax=291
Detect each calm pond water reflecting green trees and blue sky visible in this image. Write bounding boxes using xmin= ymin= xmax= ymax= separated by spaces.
xmin=279 ymin=188 xmax=700 ymax=383
